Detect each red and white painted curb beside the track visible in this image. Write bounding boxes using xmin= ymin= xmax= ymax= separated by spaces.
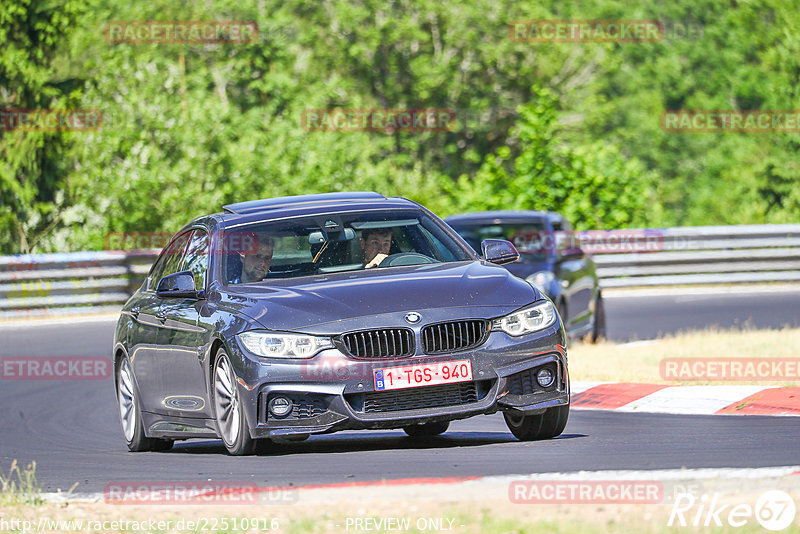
xmin=571 ymin=381 xmax=800 ymax=416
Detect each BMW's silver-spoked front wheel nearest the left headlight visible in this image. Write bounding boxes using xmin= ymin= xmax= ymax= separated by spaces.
xmin=212 ymin=349 xmax=267 ymax=456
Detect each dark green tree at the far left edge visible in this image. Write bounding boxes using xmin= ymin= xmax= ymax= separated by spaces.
xmin=0 ymin=0 xmax=84 ymax=252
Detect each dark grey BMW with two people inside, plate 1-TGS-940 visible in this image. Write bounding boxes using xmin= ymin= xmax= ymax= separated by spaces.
xmin=113 ymin=192 xmax=570 ymax=455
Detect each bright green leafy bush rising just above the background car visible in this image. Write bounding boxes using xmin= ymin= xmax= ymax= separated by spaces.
xmin=444 ymin=89 xmax=657 ymax=229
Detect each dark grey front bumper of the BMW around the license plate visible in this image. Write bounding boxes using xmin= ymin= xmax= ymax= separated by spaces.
xmin=229 ymin=324 xmax=569 ymax=438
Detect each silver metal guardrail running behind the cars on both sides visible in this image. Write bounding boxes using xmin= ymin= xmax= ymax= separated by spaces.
xmin=0 ymin=224 xmax=800 ymax=317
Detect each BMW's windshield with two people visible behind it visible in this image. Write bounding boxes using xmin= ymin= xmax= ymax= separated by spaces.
xmin=221 ymin=210 xmax=472 ymax=284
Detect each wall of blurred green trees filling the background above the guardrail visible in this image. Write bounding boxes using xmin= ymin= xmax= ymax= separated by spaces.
xmin=0 ymin=0 xmax=800 ymax=254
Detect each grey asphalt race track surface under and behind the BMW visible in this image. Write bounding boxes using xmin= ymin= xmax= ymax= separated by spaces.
xmin=0 ymin=292 xmax=800 ymax=492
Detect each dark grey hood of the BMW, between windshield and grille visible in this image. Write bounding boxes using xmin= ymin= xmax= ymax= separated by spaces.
xmin=223 ymin=261 xmax=542 ymax=333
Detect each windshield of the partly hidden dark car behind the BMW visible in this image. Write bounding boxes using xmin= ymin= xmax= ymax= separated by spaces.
xmin=451 ymin=220 xmax=552 ymax=257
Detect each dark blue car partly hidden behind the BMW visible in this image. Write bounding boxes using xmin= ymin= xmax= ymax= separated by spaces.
xmin=445 ymin=211 xmax=605 ymax=342
